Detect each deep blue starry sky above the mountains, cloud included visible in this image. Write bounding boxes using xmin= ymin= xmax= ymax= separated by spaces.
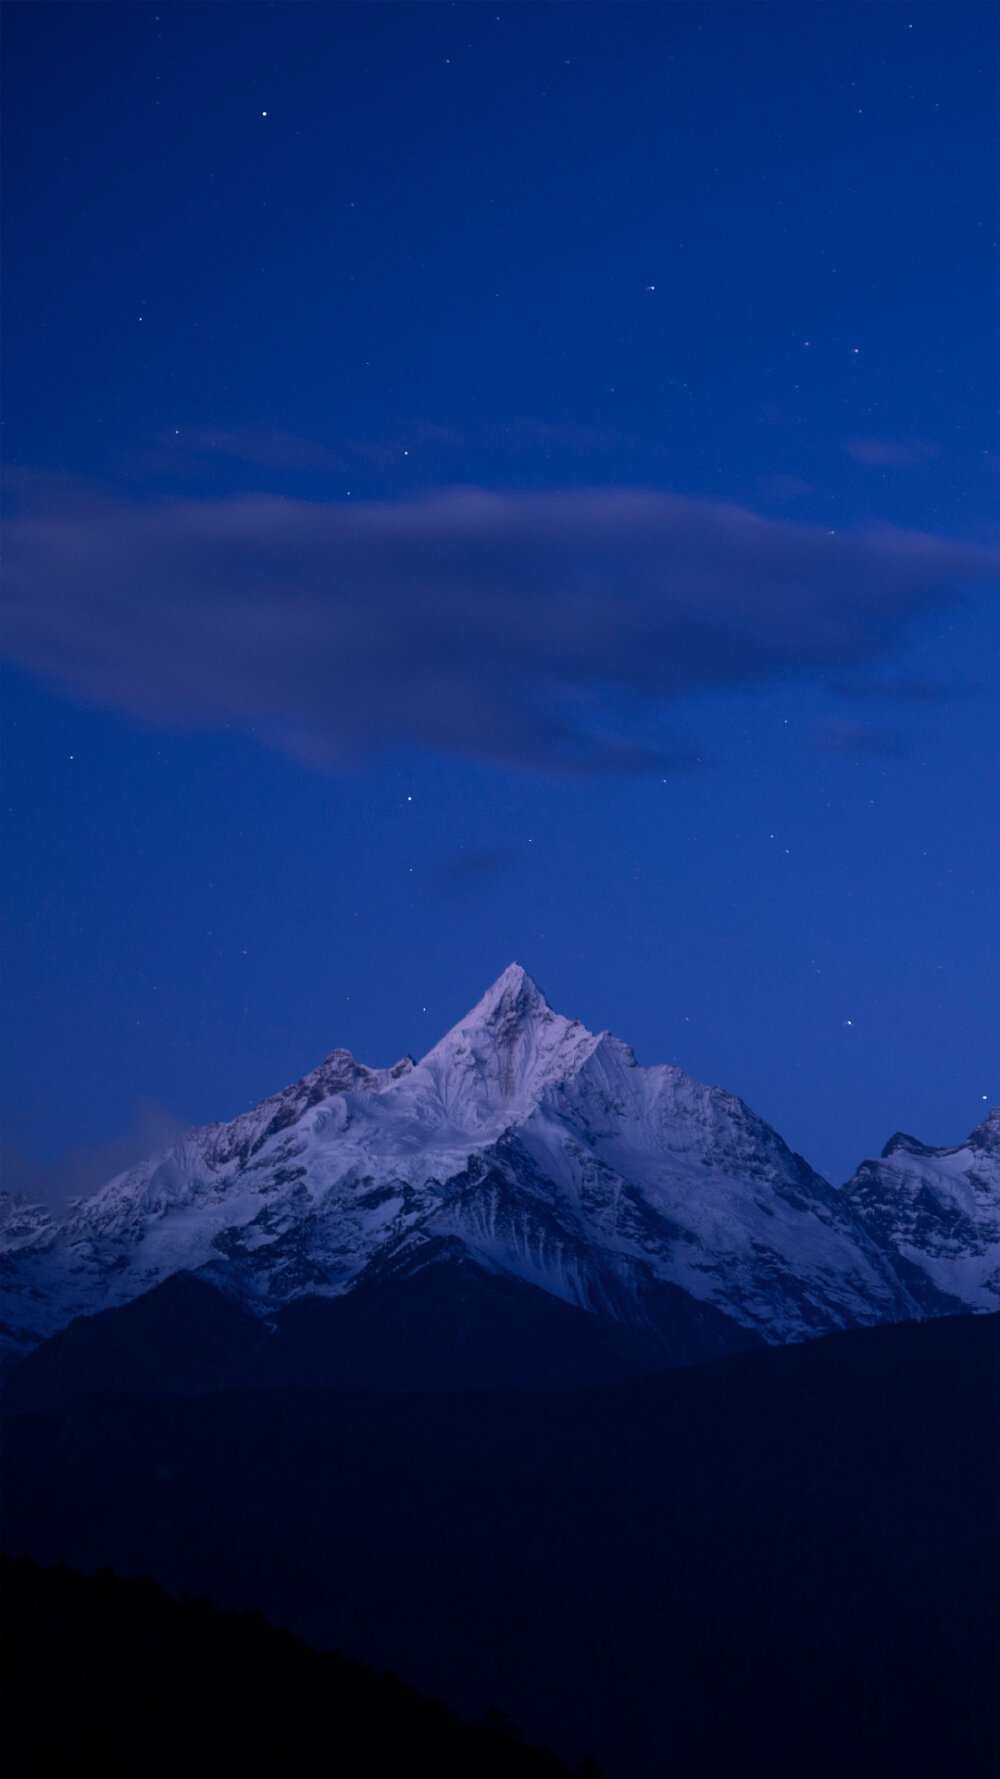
xmin=4 ymin=0 xmax=1000 ymax=1185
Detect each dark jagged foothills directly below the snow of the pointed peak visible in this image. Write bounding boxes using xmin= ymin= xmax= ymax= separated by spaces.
xmin=0 ymin=1238 xmax=760 ymax=1414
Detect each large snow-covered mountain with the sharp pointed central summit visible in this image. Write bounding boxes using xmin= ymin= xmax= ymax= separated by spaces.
xmin=0 ymin=964 xmax=996 ymax=1375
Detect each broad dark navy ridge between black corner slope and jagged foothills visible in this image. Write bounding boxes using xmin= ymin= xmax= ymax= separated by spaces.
xmin=5 ymin=1316 xmax=1000 ymax=1779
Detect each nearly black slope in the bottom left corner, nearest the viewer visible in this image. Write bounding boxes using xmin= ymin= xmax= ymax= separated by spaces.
xmin=0 ymin=1557 xmax=583 ymax=1779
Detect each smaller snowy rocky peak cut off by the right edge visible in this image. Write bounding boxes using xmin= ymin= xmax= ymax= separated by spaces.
xmin=843 ymin=1107 xmax=1000 ymax=1315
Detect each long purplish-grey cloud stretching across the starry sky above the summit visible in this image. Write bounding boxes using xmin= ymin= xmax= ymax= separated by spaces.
xmin=5 ymin=489 xmax=1000 ymax=770
